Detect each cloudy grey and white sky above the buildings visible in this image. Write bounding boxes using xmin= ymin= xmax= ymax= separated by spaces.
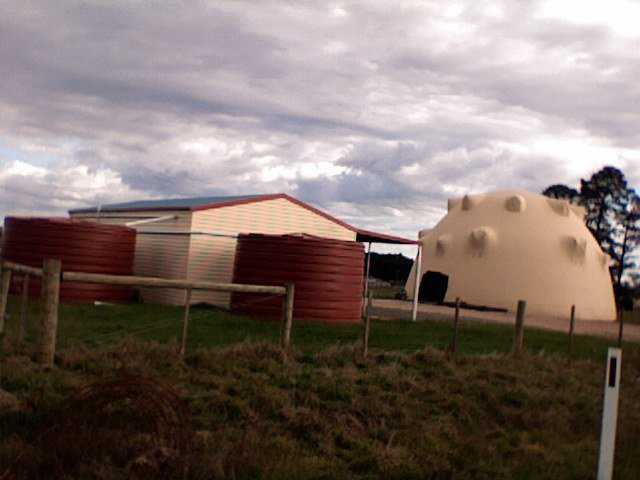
xmin=0 ymin=0 xmax=640 ymax=253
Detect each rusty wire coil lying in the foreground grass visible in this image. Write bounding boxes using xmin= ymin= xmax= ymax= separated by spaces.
xmin=27 ymin=375 xmax=193 ymax=478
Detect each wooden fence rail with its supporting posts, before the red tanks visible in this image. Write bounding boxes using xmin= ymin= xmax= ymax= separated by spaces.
xmin=0 ymin=259 xmax=294 ymax=366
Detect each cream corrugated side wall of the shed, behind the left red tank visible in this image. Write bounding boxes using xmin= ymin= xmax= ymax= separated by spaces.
xmin=71 ymin=211 xmax=191 ymax=305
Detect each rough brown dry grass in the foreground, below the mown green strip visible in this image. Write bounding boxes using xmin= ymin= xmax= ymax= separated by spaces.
xmin=0 ymin=341 xmax=640 ymax=479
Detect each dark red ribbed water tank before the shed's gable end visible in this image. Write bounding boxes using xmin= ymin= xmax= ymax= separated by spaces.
xmin=231 ymin=234 xmax=364 ymax=323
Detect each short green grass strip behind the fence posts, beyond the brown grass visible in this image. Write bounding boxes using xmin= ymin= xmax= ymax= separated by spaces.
xmin=3 ymin=299 xmax=638 ymax=360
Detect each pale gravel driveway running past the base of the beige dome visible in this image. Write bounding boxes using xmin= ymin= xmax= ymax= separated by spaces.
xmin=373 ymin=299 xmax=640 ymax=342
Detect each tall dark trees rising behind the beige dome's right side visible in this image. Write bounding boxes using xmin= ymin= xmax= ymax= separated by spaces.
xmin=542 ymin=166 xmax=640 ymax=308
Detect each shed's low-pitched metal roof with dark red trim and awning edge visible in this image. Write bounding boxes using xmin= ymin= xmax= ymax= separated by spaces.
xmin=69 ymin=193 xmax=418 ymax=245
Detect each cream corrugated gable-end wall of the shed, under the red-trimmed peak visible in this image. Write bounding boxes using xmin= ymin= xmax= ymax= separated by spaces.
xmin=188 ymin=199 xmax=356 ymax=307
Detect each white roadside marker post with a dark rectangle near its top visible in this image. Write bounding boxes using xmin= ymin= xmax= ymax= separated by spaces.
xmin=598 ymin=348 xmax=622 ymax=480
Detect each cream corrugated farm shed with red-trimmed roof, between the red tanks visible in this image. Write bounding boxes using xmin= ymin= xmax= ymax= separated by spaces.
xmin=69 ymin=193 xmax=416 ymax=308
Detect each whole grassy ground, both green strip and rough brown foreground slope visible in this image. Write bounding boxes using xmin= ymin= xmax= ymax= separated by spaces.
xmin=0 ymin=298 xmax=640 ymax=479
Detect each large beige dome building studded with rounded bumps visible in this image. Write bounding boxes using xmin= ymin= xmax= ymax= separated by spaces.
xmin=406 ymin=191 xmax=615 ymax=320
